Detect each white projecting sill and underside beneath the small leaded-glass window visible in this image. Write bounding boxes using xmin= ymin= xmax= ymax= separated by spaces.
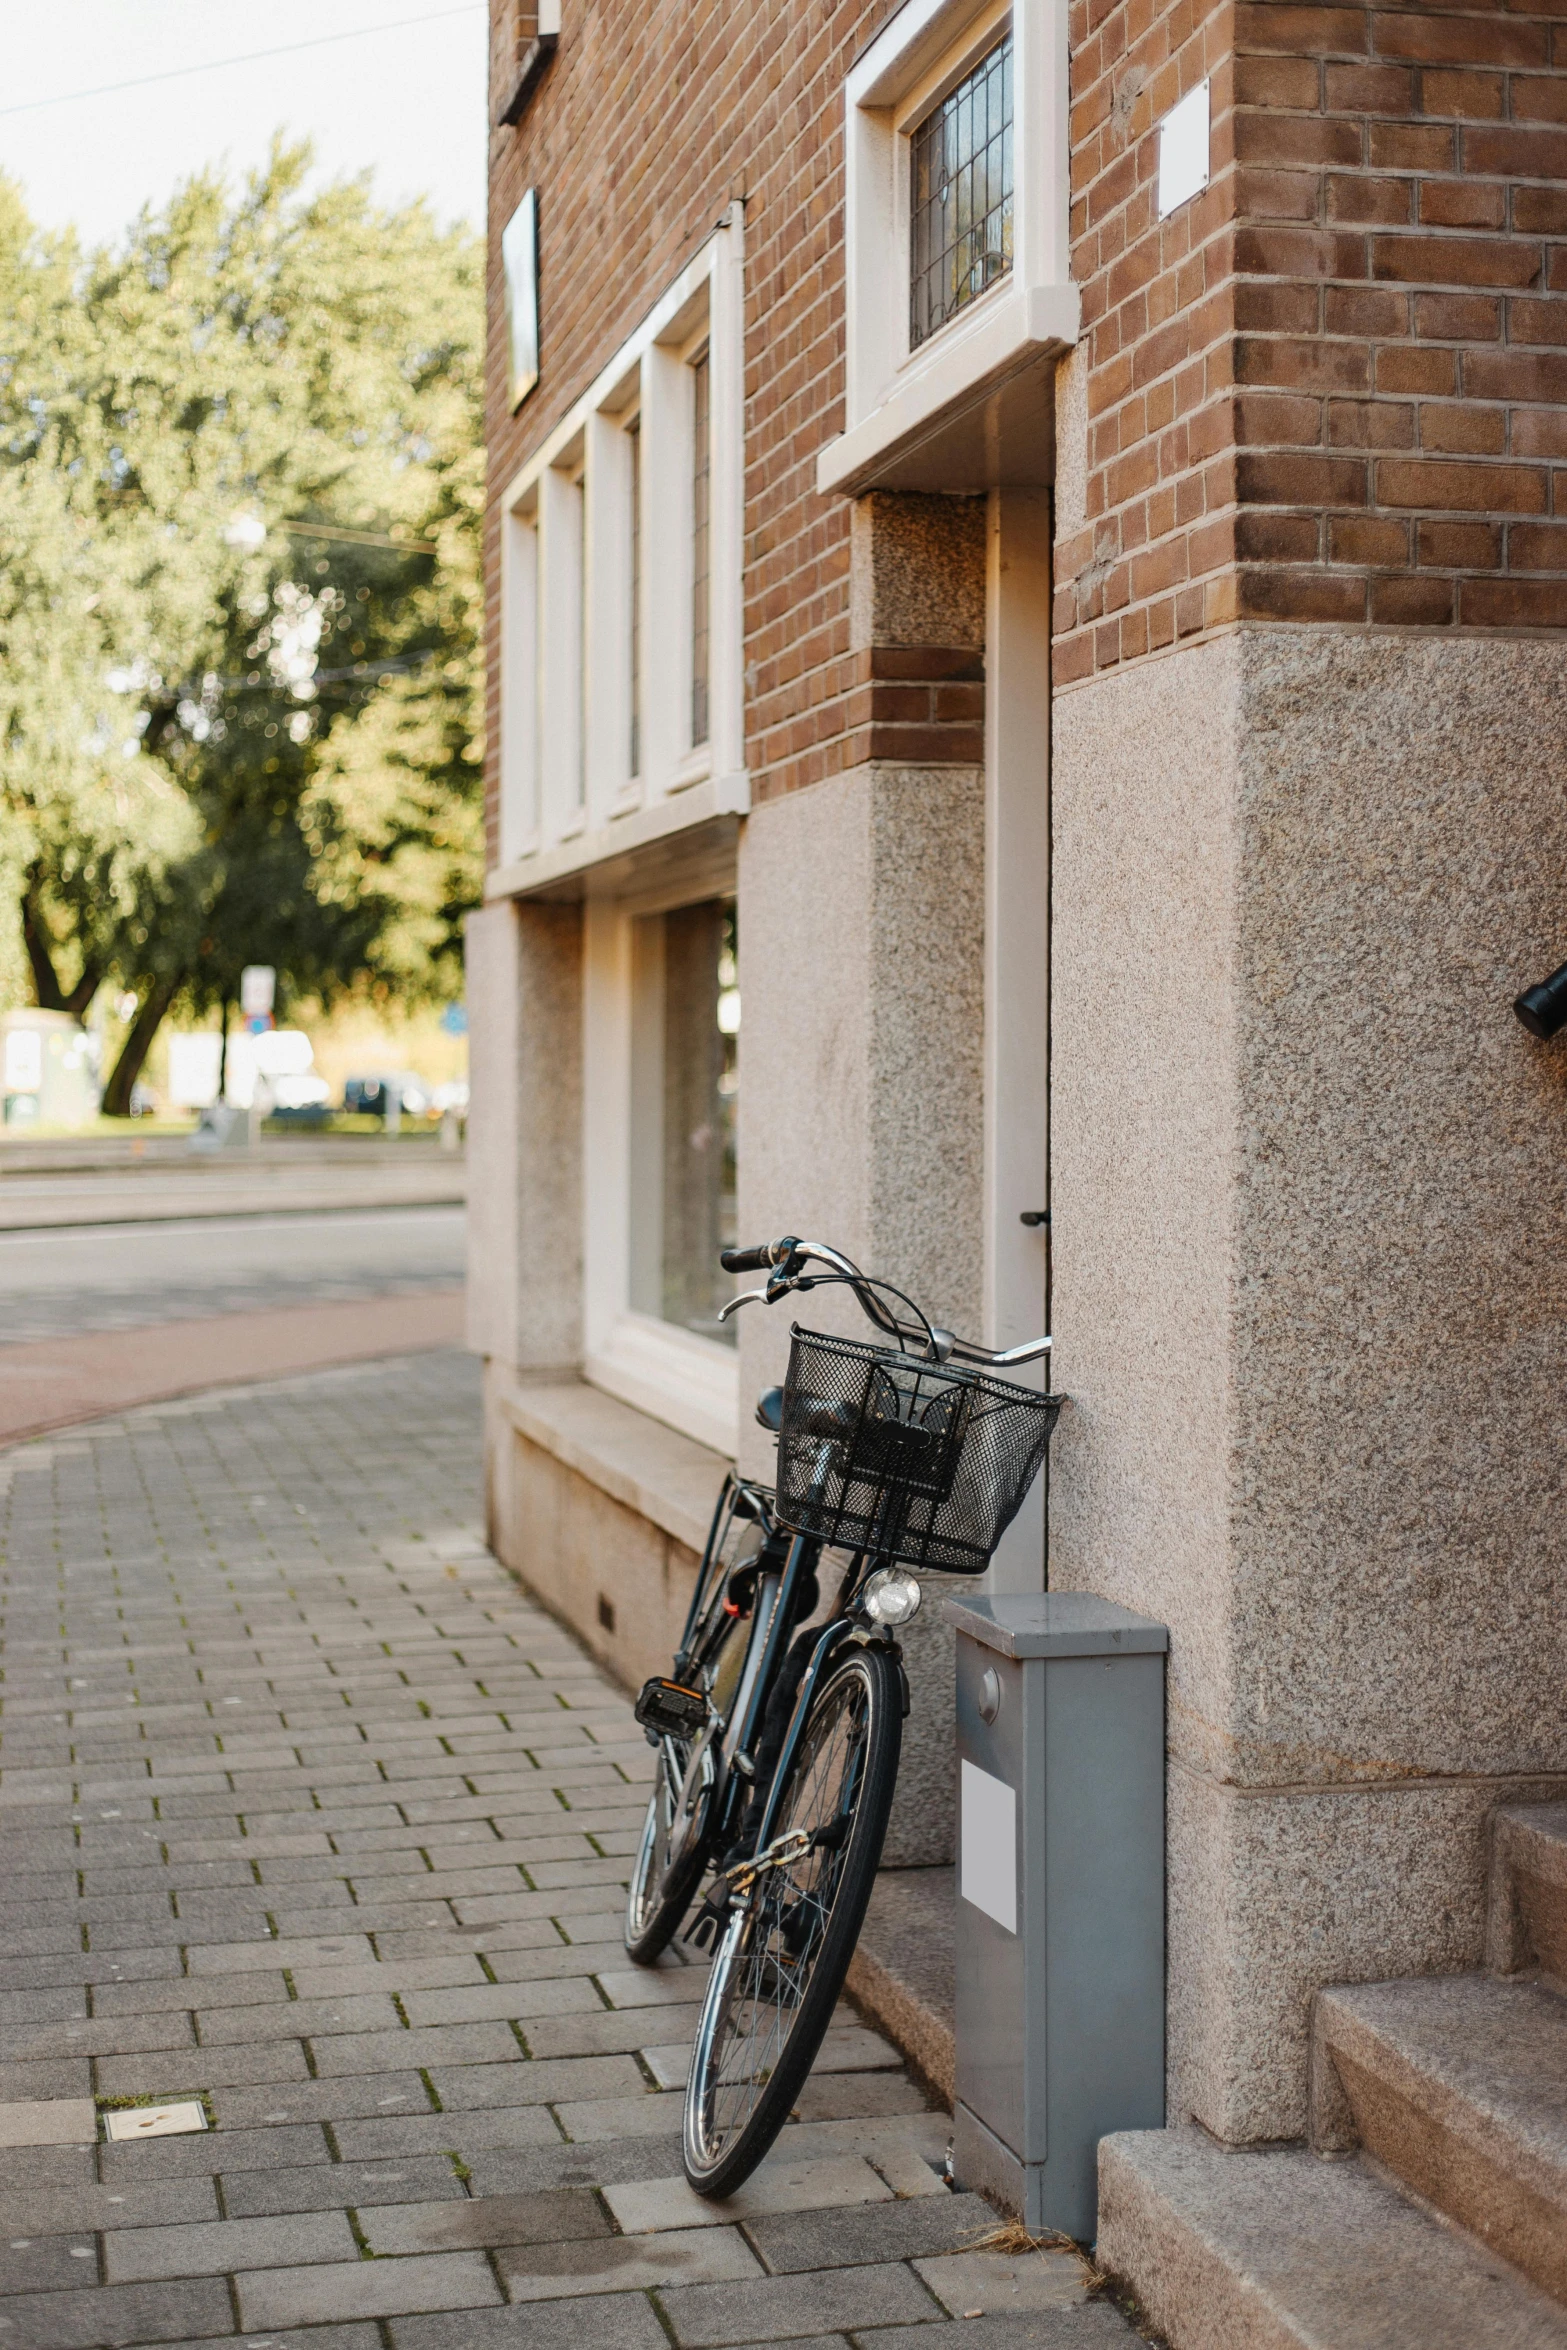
xmin=815 ymin=284 xmax=1081 ymax=496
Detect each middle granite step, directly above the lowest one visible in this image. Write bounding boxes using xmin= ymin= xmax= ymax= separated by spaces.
xmin=1313 ymin=1974 xmax=1567 ymax=2301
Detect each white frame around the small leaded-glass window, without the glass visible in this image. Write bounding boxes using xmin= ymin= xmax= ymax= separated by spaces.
xmin=818 ymin=0 xmax=1081 ymax=494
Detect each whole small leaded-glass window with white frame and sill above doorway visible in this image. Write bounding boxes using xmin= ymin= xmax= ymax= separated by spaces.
xmin=815 ymin=0 xmax=1081 ymax=494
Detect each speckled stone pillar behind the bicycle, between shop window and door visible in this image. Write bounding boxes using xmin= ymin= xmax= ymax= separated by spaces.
xmin=740 ymin=766 xmax=984 ymax=1868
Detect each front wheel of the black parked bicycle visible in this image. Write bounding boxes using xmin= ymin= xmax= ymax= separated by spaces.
xmin=684 ymin=1647 xmax=902 ymax=2197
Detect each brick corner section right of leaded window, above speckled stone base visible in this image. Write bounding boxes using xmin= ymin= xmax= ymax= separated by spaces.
xmin=1055 ymin=0 xmax=1567 ymax=682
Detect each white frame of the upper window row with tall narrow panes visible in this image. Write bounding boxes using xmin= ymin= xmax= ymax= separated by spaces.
xmin=484 ymin=204 xmax=749 ymax=898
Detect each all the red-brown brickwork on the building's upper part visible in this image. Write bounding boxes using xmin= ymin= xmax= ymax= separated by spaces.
xmin=489 ymin=0 xmax=1567 ymax=855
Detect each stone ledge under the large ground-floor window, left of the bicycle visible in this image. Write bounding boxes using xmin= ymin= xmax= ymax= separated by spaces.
xmin=500 ymin=1379 xmax=728 ymax=1553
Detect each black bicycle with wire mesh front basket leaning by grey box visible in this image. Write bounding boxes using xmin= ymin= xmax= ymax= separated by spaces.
xmin=625 ymin=1236 xmax=1060 ymax=2200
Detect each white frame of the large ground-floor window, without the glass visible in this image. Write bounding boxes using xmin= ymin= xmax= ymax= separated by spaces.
xmin=583 ymin=844 xmax=740 ymax=1459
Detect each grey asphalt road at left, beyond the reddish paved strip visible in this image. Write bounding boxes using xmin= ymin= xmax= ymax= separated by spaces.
xmin=0 ymin=1206 xmax=463 ymax=1347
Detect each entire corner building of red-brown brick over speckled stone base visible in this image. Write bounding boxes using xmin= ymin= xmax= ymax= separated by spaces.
xmin=470 ymin=0 xmax=1567 ymax=2343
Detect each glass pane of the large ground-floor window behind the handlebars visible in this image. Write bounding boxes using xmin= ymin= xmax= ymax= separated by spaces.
xmin=632 ymin=898 xmax=740 ymax=1347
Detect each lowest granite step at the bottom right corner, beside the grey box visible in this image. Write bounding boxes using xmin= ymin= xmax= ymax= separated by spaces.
xmin=1095 ymin=2129 xmax=1567 ymax=2350
